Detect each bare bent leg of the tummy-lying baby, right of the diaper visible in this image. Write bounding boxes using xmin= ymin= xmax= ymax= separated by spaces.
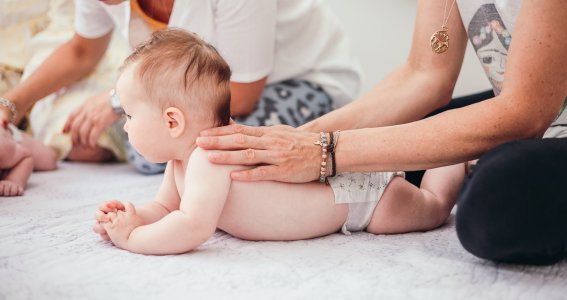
xmin=367 ymin=164 xmax=465 ymax=234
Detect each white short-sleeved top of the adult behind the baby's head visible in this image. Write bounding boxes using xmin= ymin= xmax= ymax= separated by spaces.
xmin=75 ymin=0 xmax=362 ymax=107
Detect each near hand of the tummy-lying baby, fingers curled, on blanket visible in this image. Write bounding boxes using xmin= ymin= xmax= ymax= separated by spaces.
xmin=102 ymin=202 xmax=144 ymax=249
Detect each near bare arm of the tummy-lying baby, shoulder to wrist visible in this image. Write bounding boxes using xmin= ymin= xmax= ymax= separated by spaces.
xmin=105 ymin=148 xmax=235 ymax=254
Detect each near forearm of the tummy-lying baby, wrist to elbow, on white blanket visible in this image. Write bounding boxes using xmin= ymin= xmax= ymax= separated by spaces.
xmin=126 ymin=210 xmax=216 ymax=255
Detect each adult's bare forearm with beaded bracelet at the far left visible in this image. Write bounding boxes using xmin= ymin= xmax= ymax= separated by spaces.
xmin=0 ymin=31 xmax=112 ymax=123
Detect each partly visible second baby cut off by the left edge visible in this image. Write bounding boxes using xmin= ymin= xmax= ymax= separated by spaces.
xmin=0 ymin=120 xmax=57 ymax=197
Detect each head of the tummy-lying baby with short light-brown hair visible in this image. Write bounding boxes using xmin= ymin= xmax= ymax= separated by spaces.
xmin=116 ymin=29 xmax=231 ymax=162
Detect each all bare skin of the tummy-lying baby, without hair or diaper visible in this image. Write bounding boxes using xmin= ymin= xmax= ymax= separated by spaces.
xmin=93 ymin=55 xmax=465 ymax=255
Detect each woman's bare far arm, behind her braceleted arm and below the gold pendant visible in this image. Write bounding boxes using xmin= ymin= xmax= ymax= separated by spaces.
xmin=301 ymin=1 xmax=467 ymax=132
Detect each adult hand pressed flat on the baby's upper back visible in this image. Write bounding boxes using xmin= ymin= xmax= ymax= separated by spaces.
xmin=197 ymin=124 xmax=321 ymax=183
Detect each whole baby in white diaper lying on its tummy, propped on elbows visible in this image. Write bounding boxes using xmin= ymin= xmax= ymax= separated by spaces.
xmin=93 ymin=29 xmax=465 ymax=255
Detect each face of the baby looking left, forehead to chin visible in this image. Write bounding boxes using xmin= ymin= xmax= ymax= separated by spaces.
xmin=116 ymin=66 xmax=172 ymax=163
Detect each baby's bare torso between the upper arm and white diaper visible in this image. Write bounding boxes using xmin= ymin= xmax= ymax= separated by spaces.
xmin=218 ymin=181 xmax=348 ymax=240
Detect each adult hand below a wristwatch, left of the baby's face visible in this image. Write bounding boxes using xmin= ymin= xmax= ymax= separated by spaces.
xmin=63 ymin=91 xmax=120 ymax=148
